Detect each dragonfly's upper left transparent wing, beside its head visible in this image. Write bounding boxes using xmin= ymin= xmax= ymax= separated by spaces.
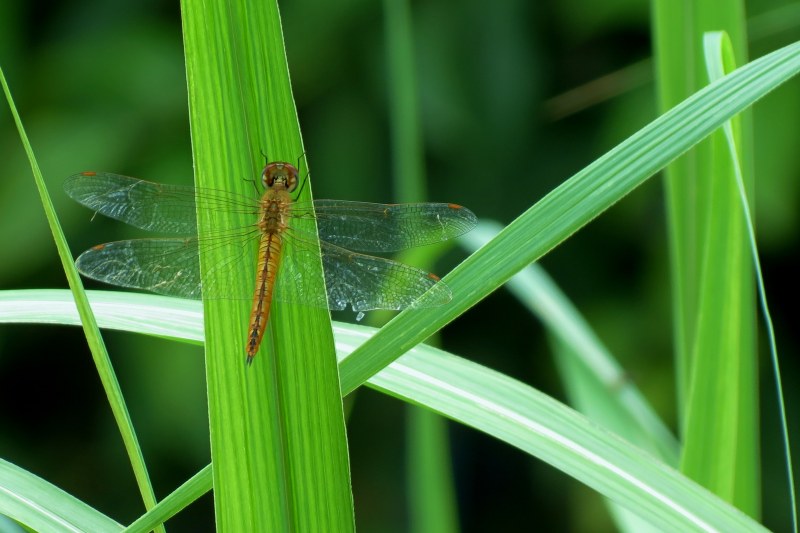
xmin=64 ymin=172 xmax=258 ymax=235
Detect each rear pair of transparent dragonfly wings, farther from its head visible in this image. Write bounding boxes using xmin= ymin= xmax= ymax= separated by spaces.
xmin=76 ymin=231 xmax=451 ymax=312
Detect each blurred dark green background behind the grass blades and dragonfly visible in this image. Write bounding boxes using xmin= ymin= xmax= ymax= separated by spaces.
xmin=0 ymin=0 xmax=800 ymax=531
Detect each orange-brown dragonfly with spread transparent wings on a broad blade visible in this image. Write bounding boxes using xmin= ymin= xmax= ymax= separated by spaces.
xmin=64 ymin=161 xmax=477 ymax=365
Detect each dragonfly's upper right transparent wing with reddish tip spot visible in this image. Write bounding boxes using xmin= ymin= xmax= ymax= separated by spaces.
xmin=292 ymin=200 xmax=477 ymax=252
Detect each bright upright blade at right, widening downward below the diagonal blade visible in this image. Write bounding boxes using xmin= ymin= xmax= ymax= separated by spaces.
xmin=681 ymin=27 xmax=761 ymax=517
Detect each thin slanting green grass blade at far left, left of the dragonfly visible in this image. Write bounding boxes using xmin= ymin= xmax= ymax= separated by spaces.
xmin=0 ymin=65 xmax=162 ymax=524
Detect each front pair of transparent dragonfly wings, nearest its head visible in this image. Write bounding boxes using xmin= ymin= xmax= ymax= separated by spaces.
xmin=64 ymin=172 xmax=477 ymax=252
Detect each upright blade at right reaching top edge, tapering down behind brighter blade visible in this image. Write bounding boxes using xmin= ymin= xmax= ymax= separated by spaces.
xmin=653 ymin=0 xmax=747 ymax=416
